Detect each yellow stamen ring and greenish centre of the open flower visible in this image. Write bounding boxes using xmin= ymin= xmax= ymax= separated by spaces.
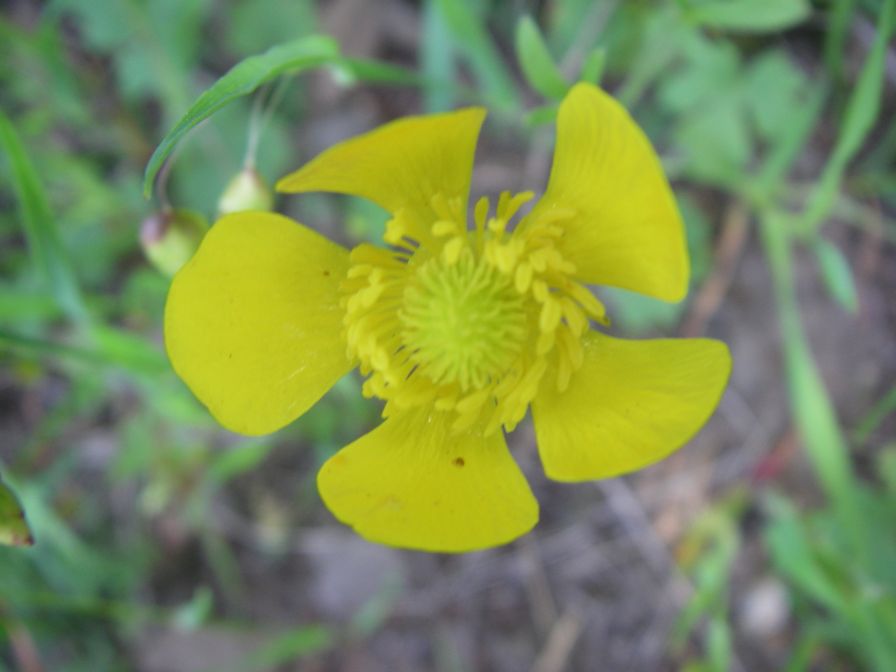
xmin=342 ymin=192 xmax=606 ymax=433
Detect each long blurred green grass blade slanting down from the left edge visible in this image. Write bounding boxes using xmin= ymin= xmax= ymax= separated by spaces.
xmin=0 ymin=111 xmax=87 ymax=323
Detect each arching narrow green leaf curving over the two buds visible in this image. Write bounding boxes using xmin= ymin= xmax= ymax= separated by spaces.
xmin=143 ymin=35 xmax=339 ymax=198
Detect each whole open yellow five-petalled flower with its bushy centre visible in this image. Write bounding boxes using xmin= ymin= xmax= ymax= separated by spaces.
xmin=165 ymin=84 xmax=731 ymax=552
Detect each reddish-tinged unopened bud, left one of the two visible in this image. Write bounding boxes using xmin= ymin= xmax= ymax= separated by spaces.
xmin=140 ymin=209 xmax=208 ymax=277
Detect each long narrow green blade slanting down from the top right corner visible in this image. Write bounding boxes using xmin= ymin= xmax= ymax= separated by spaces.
xmin=800 ymin=0 xmax=896 ymax=234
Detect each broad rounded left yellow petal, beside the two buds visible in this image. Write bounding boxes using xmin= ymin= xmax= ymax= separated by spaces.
xmin=165 ymin=212 xmax=351 ymax=434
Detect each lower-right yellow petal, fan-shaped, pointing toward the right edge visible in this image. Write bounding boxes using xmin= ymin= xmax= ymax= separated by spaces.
xmin=532 ymin=331 xmax=731 ymax=481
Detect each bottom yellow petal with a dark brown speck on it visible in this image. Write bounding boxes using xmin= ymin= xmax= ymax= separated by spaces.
xmin=317 ymin=408 xmax=538 ymax=553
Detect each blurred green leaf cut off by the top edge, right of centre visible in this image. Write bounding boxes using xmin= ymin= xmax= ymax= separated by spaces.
xmin=687 ymin=0 xmax=812 ymax=33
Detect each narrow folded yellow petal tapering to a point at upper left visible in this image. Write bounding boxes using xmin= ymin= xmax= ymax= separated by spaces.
xmin=277 ymin=108 xmax=485 ymax=245
